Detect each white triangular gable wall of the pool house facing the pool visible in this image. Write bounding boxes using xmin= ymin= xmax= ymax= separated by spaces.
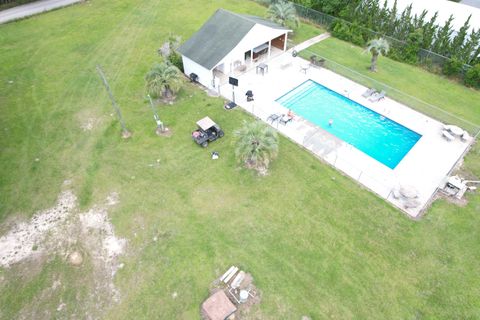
xmin=218 ymin=24 xmax=287 ymax=75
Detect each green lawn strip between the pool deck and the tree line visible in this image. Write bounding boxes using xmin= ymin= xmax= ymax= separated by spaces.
xmin=301 ymin=38 xmax=480 ymax=133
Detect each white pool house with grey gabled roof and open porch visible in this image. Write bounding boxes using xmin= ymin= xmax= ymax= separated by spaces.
xmin=178 ymin=9 xmax=291 ymax=90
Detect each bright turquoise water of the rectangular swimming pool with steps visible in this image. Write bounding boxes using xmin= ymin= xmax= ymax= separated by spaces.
xmin=277 ymin=80 xmax=422 ymax=169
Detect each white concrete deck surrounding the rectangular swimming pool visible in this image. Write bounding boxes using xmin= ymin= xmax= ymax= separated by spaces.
xmin=220 ymin=52 xmax=472 ymax=218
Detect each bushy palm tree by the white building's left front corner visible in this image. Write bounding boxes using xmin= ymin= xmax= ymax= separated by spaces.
xmin=145 ymin=62 xmax=182 ymax=99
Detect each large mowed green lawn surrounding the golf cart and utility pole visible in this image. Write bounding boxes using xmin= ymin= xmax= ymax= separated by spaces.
xmin=0 ymin=0 xmax=480 ymax=319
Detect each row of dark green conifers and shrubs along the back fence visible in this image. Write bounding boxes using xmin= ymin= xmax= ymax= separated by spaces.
xmin=284 ymin=0 xmax=480 ymax=86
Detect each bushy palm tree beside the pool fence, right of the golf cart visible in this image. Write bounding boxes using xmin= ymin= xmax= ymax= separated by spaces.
xmin=235 ymin=121 xmax=278 ymax=175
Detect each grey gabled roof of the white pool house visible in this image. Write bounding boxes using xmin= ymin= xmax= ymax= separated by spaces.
xmin=178 ymin=9 xmax=288 ymax=70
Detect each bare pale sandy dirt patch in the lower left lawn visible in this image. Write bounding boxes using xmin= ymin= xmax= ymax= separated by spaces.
xmin=0 ymin=186 xmax=127 ymax=318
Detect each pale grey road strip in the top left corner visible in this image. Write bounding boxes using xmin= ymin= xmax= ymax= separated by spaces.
xmin=0 ymin=0 xmax=82 ymax=24
